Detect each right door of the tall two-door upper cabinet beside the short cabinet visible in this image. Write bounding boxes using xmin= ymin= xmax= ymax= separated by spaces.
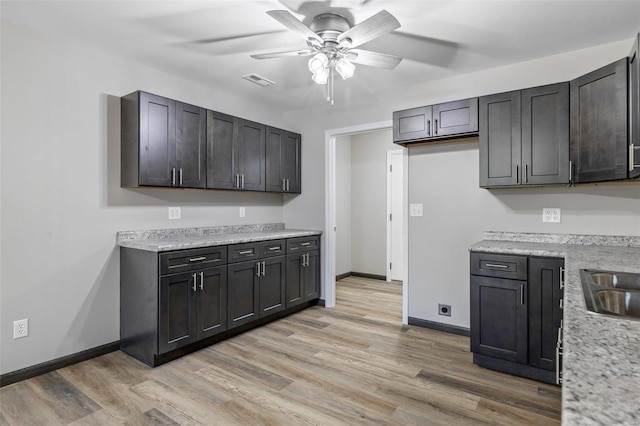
xmin=522 ymin=83 xmax=569 ymax=185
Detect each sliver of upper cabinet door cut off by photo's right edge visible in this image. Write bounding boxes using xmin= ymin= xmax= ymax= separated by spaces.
xmin=629 ymin=34 xmax=640 ymax=178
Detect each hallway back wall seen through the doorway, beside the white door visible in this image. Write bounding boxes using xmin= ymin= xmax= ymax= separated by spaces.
xmin=351 ymin=129 xmax=398 ymax=277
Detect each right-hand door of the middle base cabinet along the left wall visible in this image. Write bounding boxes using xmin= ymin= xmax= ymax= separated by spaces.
xmin=260 ymin=256 xmax=286 ymax=317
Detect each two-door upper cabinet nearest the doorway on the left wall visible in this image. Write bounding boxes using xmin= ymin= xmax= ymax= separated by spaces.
xmin=265 ymin=126 xmax=301 ymax=194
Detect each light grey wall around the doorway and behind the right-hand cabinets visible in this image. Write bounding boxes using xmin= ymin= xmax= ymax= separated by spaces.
xmin=284 ymin=40 xmax=640 ymax=327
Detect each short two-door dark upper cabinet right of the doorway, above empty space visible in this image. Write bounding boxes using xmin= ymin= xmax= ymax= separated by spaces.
xmin=393 ymin=98 xmax=478 ymax=145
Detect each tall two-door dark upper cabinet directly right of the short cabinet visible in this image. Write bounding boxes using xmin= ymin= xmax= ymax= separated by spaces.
xmin=479 ymin=82 xmax=569 ymax=188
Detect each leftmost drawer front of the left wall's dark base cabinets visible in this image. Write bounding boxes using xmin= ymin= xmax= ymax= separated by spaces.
xmin=160 ymin=246 xmax=227 ymax=275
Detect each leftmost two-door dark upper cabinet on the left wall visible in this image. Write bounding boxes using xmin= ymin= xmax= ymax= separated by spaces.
xmin=121 ymin=91 xmax=206 ymax=188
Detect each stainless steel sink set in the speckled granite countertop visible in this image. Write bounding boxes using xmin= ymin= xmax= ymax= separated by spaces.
xmin=580 ymin=269 xmax=640 ymax=320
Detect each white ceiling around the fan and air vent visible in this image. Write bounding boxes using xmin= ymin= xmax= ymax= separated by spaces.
xmin=0 ymin=0 xmax=640 ymax=110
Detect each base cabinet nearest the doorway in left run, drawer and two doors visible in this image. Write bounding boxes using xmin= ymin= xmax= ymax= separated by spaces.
xmin=286 ymin=237 xmax=320 ymax=308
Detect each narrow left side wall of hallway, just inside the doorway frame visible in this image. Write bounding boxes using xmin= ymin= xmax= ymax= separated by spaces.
xmin=336 ymin=135 xmax=353 ymax=275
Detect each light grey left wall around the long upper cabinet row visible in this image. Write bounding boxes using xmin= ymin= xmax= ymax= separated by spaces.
xmin=0 ymin=22 xmax=288 ymax=373
